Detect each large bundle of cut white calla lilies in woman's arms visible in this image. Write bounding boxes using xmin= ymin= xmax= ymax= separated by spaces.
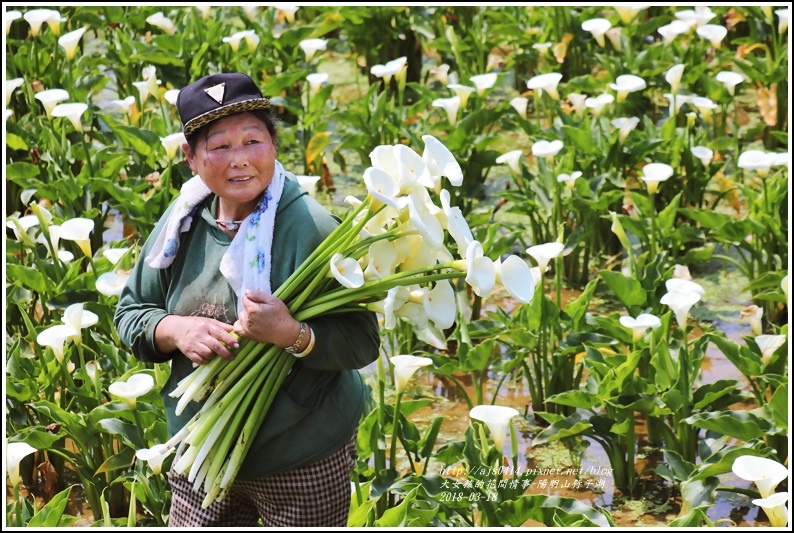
xmin=168 ymin=135 xmax=535 ymax=507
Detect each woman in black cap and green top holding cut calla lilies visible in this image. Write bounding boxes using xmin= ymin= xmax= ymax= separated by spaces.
xmin=115 ymin=73 xmax=380 ymax=527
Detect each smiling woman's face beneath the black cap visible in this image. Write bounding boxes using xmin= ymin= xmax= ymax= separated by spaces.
xmin=183 ymin=113 xmax=277 ymax=205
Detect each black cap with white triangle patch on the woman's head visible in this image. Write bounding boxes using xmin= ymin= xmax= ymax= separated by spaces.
xmin=176 ymin=72 xmax=270 ymax=138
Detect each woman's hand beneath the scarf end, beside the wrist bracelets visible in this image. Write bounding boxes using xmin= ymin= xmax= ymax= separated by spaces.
xmin=234 ymin=290 xmax=300 ymax=348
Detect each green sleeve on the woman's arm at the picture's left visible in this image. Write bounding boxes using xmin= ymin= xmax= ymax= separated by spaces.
xmin=113 ymin=204 xmax=178 ymax=363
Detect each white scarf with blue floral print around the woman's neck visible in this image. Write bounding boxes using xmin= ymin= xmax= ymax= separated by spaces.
xmin=146 ymin=161 xmax=285 ymax=313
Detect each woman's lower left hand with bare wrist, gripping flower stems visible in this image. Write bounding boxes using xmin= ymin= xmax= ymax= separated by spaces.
xmin=154 ymin=315 xmax=239 ymax=365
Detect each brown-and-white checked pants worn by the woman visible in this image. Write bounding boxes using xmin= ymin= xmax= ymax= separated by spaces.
xmin=168 ymin=433 xmax=356 ymax=527
